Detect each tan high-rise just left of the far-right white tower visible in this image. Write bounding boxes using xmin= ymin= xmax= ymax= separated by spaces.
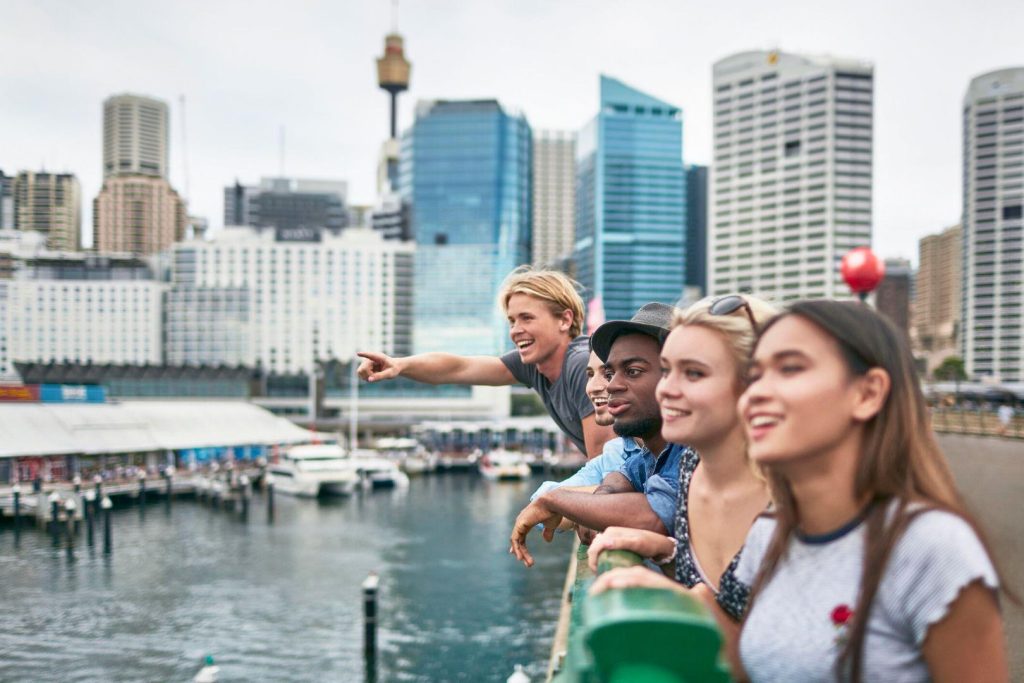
xmin=910 ymin=225 xmax=964 ymax=372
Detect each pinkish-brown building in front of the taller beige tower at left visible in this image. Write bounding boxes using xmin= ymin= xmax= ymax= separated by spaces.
xmin=92 ymin=175 xmax=187 ymax=255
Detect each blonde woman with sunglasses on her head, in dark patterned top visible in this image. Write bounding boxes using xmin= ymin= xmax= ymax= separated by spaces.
xmin=589 ymin=295 xmax=776 ymax=629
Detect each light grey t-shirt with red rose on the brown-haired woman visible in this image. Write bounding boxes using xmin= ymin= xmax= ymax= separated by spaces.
xmin=736 ymin=510 xmax=998 ymax=683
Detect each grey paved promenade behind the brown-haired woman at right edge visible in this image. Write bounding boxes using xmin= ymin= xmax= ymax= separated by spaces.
xmin=939 ymin=434 xmax=1024 ymax=681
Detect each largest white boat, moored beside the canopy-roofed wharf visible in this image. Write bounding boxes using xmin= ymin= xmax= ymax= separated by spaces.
xmin=267 ymin=443 xmax=359 ymax=498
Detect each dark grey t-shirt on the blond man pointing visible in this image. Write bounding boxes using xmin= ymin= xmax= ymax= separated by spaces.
xmin=502 ymin=335 xmax=594 ymax=455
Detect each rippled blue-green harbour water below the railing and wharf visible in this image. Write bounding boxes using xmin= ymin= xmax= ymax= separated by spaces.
xmin=0 ymin=474 xmax=571 ymax=682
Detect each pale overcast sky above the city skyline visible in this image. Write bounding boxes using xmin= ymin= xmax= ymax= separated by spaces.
xmin=0 ymin=0 xmax=1024 ymax=261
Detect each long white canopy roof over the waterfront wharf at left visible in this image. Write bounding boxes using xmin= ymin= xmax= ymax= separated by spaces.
xmin=0 ymin=400 xmax=317 ymax=458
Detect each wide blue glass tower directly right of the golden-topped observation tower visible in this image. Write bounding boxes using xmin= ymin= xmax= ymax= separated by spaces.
xmin=399 ymin=99 xmax=531 ymax=354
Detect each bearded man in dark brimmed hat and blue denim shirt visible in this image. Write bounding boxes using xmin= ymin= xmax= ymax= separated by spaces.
xmin=509 ymin=303 xmax=686 ymax=566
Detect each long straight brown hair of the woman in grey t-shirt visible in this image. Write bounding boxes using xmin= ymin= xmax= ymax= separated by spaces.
xmin=746 ymin=300 xmax=1013 ymax=681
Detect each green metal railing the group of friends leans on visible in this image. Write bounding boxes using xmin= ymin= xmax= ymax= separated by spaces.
xmin=552 ymin=546 xmax=731 ymax=683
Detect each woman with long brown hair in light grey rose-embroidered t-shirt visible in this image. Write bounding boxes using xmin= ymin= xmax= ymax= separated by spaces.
xmin=736 ymin=301 xmax=1008 ymax=681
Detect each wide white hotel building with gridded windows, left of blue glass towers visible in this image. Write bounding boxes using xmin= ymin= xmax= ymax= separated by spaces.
xmin=165 ymin=226 xmax=415 ymax=374
